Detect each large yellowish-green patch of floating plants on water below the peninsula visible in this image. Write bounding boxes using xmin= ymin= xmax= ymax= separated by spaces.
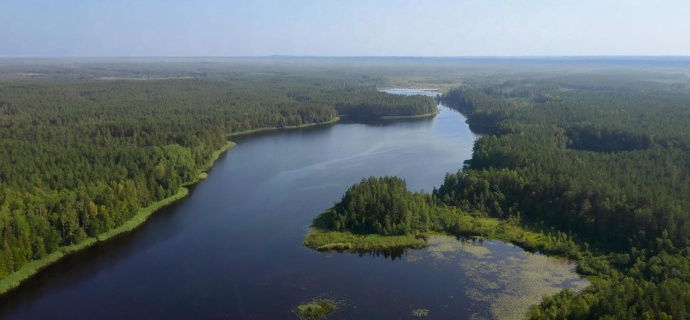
xmin=408 ymin=235 xmax=589 ymax=319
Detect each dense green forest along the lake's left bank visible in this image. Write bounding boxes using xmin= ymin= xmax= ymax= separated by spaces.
xmin=0 ymin=61 xmax=436 ymax=279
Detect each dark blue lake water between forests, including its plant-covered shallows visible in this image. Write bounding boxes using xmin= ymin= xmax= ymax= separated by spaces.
xmin=0 ymin=90 xmax=587 ymax=319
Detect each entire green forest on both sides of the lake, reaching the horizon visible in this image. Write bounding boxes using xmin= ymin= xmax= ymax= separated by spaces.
xmin=0 ymin=58 xmax=690 ymax=319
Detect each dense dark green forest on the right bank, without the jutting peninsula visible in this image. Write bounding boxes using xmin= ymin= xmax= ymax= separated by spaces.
xmin=433 ymin=73 xmax=690 ymax=319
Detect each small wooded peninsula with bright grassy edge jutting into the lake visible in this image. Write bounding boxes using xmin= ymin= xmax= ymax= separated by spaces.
xmin=304 ymin=177 xmax=580 ymax=258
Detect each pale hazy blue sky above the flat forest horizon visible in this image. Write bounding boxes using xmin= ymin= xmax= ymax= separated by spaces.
xmin=0 ymin=0 xmax=690 ymax=57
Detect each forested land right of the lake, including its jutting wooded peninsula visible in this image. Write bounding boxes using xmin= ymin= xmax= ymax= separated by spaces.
xmin=305 ymin=58 xmax=690 ymax=319
